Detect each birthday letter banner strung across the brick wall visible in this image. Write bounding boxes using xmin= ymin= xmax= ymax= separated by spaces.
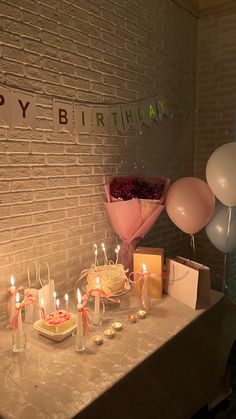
xmin=0 ymin=86 xmax=169 ymax=134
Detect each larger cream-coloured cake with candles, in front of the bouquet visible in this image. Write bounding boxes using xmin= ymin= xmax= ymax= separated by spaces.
xmin=87 ymin=264 xmax=129 ymax=296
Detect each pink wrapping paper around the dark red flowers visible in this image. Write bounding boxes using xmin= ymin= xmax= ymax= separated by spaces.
xmin=104 ymin=178 xmax=169 ymax=272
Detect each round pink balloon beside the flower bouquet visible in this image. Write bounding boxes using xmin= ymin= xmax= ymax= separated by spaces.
xmin=166 ymin=177 xmax=215 ymax=234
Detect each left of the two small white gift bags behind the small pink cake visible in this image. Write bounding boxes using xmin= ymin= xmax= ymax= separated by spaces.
xmin=25 ymin=262 xmax=40 ymax=323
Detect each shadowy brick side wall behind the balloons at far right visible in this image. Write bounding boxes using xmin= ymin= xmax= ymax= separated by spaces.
xmin=194 ymin=2 xmax=236 ymax=300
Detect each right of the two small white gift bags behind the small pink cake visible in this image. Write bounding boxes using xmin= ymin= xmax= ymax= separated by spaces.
xmin=38 ymin=262 xmax=55 ymax=314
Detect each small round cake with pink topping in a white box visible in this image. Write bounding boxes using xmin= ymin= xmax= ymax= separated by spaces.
xmin=39 ymin=310 xmax=76 ymax=334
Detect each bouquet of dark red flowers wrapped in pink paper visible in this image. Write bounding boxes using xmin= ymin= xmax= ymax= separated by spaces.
xmin=104 ymin=177 xmax=170 ymax=272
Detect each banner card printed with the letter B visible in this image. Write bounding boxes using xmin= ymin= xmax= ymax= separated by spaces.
xmin=53 ymin=99 xmax=74 ymax=133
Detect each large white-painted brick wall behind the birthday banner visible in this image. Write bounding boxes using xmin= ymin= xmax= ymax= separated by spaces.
xmin=0 ymin=0 xmax=197 ymax=319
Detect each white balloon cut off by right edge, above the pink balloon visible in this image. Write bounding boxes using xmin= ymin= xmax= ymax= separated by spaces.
xmin=206 ymin=141 xmax=236 ymax=206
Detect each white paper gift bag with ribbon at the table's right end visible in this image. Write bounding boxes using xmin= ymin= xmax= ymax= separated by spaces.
xmin=164 ymin=256 xmax=211 ymax=309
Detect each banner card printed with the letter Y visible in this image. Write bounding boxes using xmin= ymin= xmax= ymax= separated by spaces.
xmin=11 ymin=90 xmax=36 ymax=128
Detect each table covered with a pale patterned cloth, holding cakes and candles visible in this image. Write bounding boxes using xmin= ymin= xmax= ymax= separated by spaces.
xmin=0 ymin=291 xmax=236 ymax=419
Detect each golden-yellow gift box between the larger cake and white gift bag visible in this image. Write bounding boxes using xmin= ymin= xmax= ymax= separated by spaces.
xmin=133 ymin=247 xmax=164 ymax=298
